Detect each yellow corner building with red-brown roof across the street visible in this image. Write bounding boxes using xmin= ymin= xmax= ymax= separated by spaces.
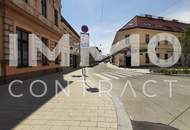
xmin=111 ymin=15 xmax=188 ymax=67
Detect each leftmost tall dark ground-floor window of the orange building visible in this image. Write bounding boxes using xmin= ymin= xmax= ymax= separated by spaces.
xmin=17 ymin=28 xmax=29 ymax=67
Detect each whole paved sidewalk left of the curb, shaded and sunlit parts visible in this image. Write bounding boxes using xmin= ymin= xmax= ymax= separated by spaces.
xmin=0 ymin=70 xmax=117 ymax=130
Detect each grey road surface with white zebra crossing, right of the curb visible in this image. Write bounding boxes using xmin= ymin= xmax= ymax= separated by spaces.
xmin=89 ymin=64 xmax=190 ymax=130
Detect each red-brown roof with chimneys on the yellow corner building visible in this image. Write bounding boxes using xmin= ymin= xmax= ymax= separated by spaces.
xmin=119 ymin=15 xmax=190 ymax=32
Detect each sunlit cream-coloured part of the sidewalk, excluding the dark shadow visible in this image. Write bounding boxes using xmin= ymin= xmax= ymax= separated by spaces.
xmin=10 ymin=70 xmax=118 ymax=130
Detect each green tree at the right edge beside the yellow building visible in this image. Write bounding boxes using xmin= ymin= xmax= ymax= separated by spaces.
xmin=181 ymin=26 xmax=190 ymax=67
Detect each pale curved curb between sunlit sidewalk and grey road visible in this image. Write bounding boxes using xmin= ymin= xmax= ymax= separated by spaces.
xmin=112 ymin=96 xmax=133 ymax=130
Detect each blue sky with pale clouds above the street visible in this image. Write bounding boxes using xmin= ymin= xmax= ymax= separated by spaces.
xmin=61 ymin=0 xmax=190 ymax=55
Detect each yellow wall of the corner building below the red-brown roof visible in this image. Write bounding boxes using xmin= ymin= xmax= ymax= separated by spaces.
xmin=112 ymin=28 xmax=182 ymax=66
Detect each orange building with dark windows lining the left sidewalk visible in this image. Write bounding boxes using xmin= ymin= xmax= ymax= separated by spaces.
xmin=0 ymin=0 xmax=80 ymax=81
